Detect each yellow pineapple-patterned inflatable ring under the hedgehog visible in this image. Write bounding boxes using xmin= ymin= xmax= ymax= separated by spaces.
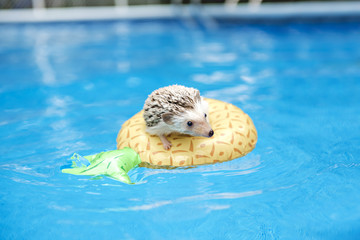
xmin=116 ymin=98 xmax=257 ymax=167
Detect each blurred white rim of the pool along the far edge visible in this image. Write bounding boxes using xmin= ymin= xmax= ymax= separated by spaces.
xmin=0 ymin=1 xmax=360 ymax=23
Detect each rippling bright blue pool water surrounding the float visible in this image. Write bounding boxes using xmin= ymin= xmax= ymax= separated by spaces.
xmin=0 ymin=19 xmax=360 ymax=240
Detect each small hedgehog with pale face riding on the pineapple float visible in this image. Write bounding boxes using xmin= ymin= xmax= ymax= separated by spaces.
xmin=143 ymin=85 xmax=214 ymax=150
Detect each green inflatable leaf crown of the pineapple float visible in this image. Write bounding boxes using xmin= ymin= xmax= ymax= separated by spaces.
xmin=62 ymin=147 xmax=141 ymax=184
